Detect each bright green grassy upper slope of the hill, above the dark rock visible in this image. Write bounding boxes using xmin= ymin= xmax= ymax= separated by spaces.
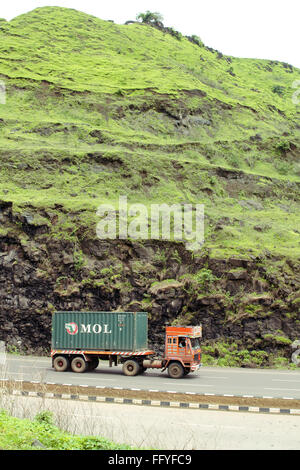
xmin=0 ymin=7 xmax=300 ymax=257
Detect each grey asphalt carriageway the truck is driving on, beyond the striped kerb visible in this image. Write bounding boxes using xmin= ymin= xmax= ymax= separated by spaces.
xmin=0 ymin=355 xmax=300 ymax=399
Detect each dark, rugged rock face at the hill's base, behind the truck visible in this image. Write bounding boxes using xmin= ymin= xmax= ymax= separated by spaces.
xmin=0 ymin=203 xmax=300 ymax=363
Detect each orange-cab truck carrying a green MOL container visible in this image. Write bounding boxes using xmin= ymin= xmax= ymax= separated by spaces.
xmin=51 ymin=312 xmax=202 ymax=379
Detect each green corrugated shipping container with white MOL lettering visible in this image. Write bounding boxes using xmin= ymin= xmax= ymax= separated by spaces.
xmin=52 ymin=312 xmax=148 ymax=351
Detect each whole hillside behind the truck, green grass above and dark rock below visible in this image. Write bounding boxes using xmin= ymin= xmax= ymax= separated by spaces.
xmin=0 ymin=7 xmax=300 ymax=363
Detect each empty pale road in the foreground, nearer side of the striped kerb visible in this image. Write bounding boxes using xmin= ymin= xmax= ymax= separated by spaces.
xmin=0 ymin=396 xmax=300 ymax=452
